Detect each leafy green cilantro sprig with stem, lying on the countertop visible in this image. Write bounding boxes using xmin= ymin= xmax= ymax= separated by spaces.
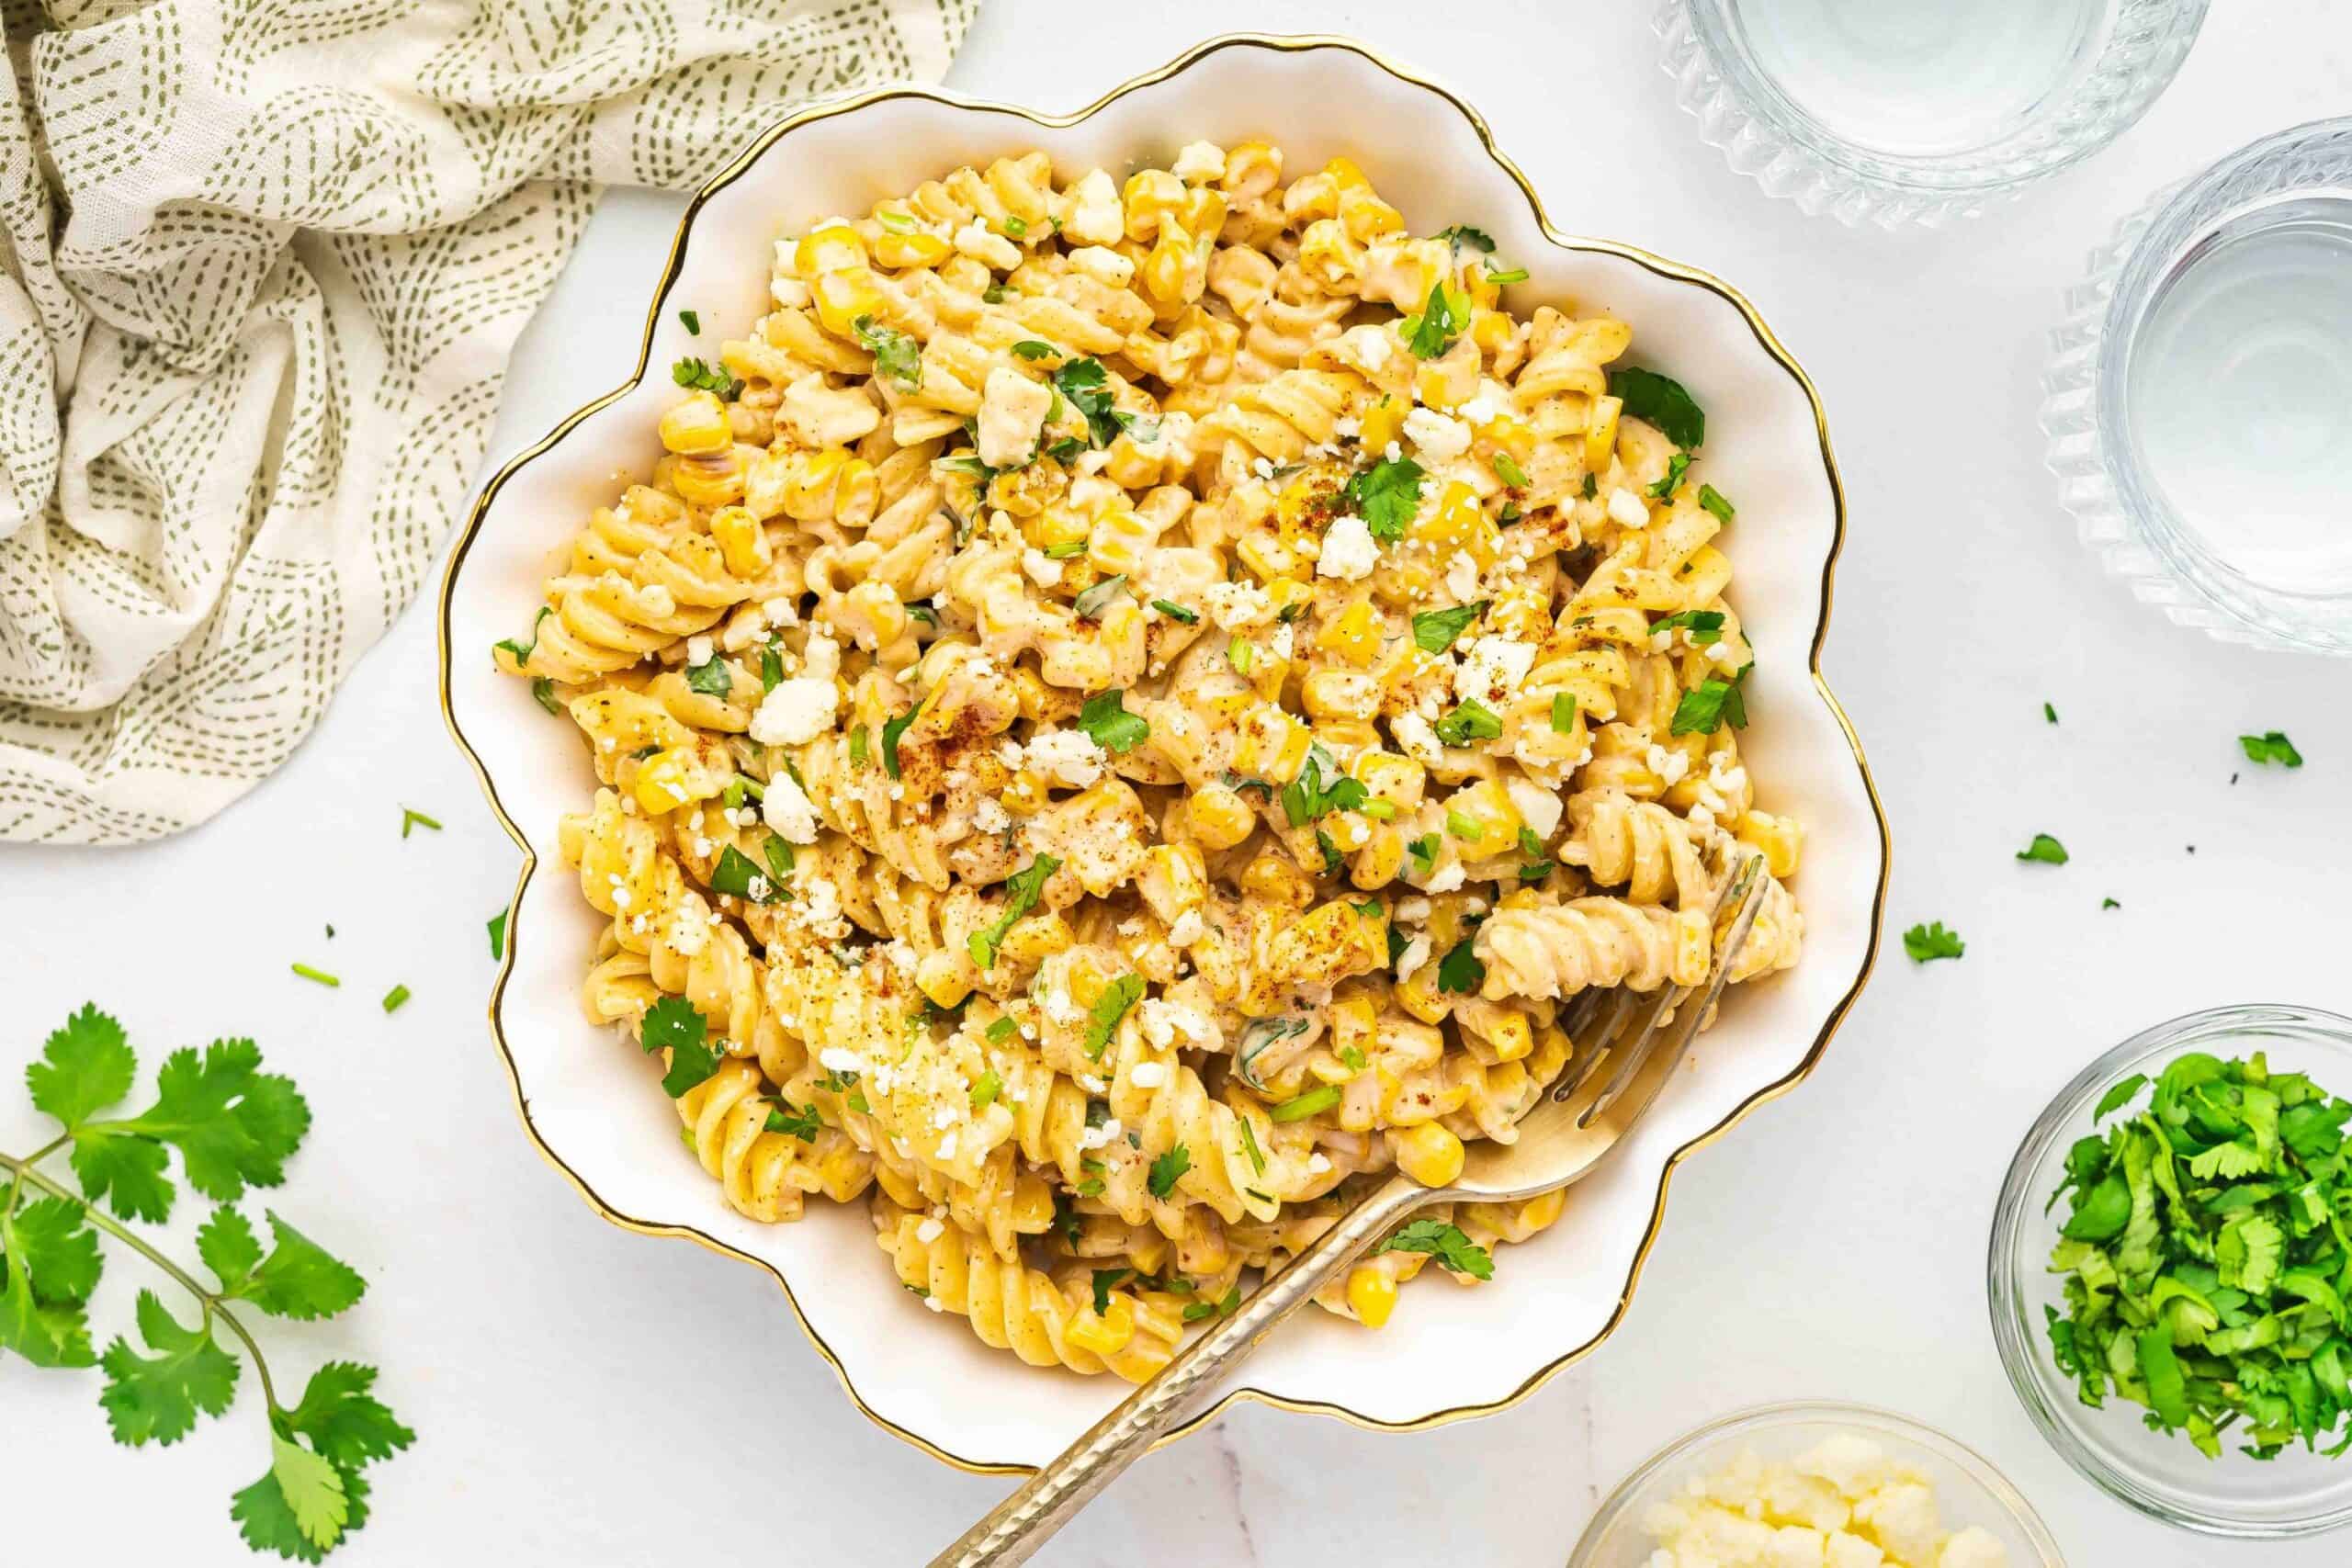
xmin=0 ymin=1006 xmax=416 ymax=1563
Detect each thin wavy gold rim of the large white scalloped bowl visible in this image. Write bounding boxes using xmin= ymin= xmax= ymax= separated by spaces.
xmin=437 ymin=33 xmax=1894 ymax=1474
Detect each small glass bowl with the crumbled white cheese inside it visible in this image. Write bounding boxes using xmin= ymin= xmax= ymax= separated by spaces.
xmin=1569 ymin=1404 xmax=2063 ymax=1568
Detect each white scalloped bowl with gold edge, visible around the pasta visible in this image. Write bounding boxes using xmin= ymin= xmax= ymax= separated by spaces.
xmin=442 ymin=38 xmax=1886 ymax=1470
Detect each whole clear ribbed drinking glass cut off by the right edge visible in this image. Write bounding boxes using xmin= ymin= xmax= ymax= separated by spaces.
xmin=2041 ymin=118 xmax=2352 ymax=653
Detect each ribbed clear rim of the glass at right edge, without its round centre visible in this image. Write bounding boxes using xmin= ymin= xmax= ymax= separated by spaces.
xmin=2041 ymin=118 xmax=2352 ymax=653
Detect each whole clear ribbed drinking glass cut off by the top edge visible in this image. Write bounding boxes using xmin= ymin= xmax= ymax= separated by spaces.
xmin=1656 ymin=0 xmax=2206 ymax=228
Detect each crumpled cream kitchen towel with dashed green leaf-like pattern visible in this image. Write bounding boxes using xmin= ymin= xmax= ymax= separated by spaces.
xmin=0 ymin=0 xmax=978 ymax=846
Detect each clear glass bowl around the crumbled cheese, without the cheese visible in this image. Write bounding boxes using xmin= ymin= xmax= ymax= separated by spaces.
xmin=1569 ymin=1399 xmax=2065 ymax=1568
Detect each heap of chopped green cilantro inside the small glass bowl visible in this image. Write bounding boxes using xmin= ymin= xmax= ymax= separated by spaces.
xmin=2044 ymin=1051 xmax=2352 ymax=1460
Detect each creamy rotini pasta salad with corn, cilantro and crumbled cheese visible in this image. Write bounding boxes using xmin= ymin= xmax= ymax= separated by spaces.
xmin=496 ymin=141 xmax=1802 ymax=1380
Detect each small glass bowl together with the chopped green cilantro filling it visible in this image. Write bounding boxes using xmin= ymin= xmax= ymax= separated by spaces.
xmin=1987 ymin=1006 xmax=2352 ymax=1540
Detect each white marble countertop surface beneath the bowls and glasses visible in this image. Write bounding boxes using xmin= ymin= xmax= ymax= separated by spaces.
xmin=0 ymin=0 xmax=2352 ymax=1568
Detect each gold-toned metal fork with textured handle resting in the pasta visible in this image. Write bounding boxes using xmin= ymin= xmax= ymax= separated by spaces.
xmin=932 ymin=856 xmax=1764 ymax=1568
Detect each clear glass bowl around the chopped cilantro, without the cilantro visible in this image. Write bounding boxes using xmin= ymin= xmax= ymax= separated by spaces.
xmin=1987 ymin=1006 xmax=2352 ymax=1540
